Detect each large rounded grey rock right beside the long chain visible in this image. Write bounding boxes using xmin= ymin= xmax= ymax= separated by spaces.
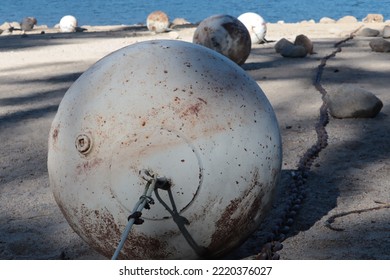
xmin=325 ymin=84 xmax=383 ymax=118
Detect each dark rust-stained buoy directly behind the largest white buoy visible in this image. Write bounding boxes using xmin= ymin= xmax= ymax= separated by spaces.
xmin=193 ymin=15 xmax=251 ymax=65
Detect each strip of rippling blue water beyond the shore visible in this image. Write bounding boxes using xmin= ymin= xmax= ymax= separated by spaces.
xmin=0 ymin=0 xmax=390 ymax=26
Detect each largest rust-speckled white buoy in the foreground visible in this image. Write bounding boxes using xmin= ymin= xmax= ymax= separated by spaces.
xmin=48 ymin=40 xmax=282 ymax=259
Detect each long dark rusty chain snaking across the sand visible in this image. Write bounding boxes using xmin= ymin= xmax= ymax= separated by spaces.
xmin=255 ymin=27 xmax=361 ymax=260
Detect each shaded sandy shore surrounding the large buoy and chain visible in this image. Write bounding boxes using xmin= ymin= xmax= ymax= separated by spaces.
xmin=0 ymin=22 xmax=390 ymax=259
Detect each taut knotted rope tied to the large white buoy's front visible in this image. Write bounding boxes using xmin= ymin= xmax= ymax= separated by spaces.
xmin=111 ymin=175 xmax=157 ymax=260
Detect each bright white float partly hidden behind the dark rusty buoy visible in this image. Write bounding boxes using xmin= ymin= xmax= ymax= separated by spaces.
xmin=238 ymin=12 xmax=267 ymax=44
